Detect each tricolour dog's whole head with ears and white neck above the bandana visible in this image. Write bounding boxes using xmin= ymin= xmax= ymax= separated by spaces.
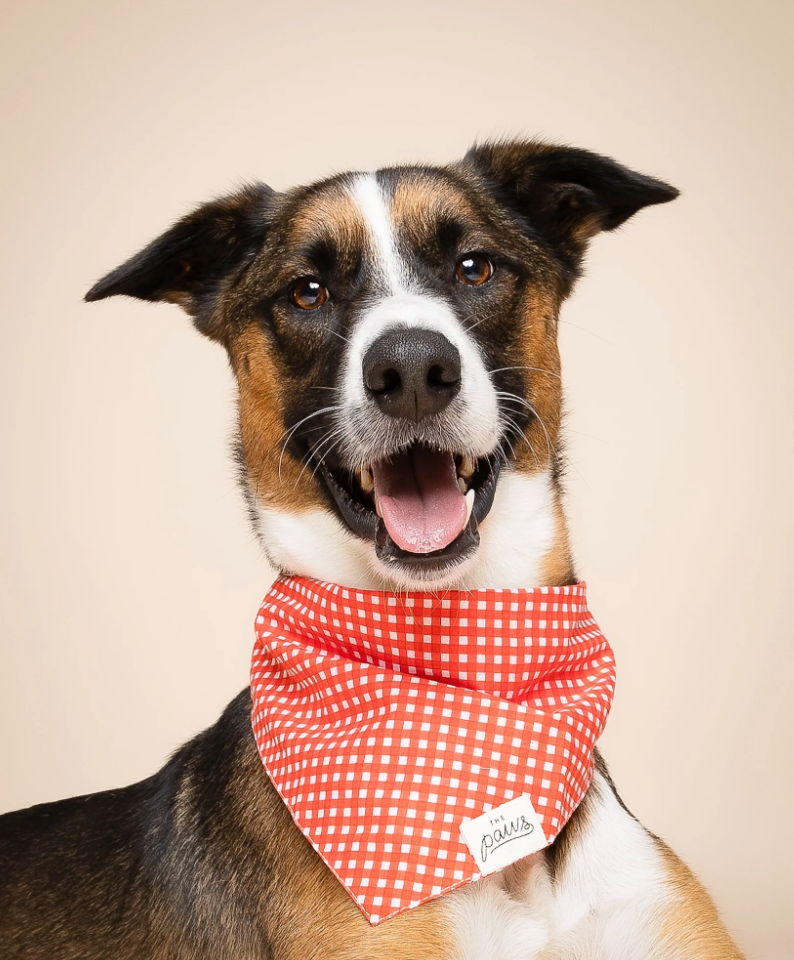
xmin=87 ymin=143 xmax=676 ymax=588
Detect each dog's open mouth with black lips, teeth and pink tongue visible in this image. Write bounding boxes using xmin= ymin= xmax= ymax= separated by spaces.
xmin=321 ymin=443 xmax=499 ymax=577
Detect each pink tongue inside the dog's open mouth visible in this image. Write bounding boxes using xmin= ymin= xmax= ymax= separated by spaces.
xmin=372 ymin=447 xmax=466 ymax=553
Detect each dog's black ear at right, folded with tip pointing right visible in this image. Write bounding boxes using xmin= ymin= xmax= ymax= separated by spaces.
xmin=463 ymin=141 xmax=678 ymax=268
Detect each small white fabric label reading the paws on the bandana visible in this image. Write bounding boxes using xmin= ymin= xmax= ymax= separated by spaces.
xmin=460 ymin=794 xmax=547 ymax=874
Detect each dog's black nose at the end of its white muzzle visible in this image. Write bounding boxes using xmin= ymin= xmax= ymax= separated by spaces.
xmin=363 ymin=328 xmax=460 ymax=420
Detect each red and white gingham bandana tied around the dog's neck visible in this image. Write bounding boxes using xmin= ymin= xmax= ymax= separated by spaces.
xmin=251 ymin=577 xmax=615 ymax=924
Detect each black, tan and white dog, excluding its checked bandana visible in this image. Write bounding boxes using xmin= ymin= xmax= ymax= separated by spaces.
xmin=0 ymin=141 xmax=741 ymax=960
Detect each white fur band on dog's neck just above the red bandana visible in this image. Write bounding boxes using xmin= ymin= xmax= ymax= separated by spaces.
xmin=256 ymin=470 xmax=575 ymax=590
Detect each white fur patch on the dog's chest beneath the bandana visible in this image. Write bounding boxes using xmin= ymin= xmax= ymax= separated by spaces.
xmin=444 ymin=773 xmax=671 ymax=960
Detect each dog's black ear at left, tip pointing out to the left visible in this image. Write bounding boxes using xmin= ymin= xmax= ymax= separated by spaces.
xmin=85 ymin=183 xmax=275 ymax=340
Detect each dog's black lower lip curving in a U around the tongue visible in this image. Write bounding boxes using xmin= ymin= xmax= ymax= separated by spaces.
xmin=318 ymin=453 xmax=500 ymax=579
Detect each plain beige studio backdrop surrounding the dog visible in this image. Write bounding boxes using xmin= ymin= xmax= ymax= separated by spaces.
xmin=0 ymin=0 xmax=794 ymax=960
